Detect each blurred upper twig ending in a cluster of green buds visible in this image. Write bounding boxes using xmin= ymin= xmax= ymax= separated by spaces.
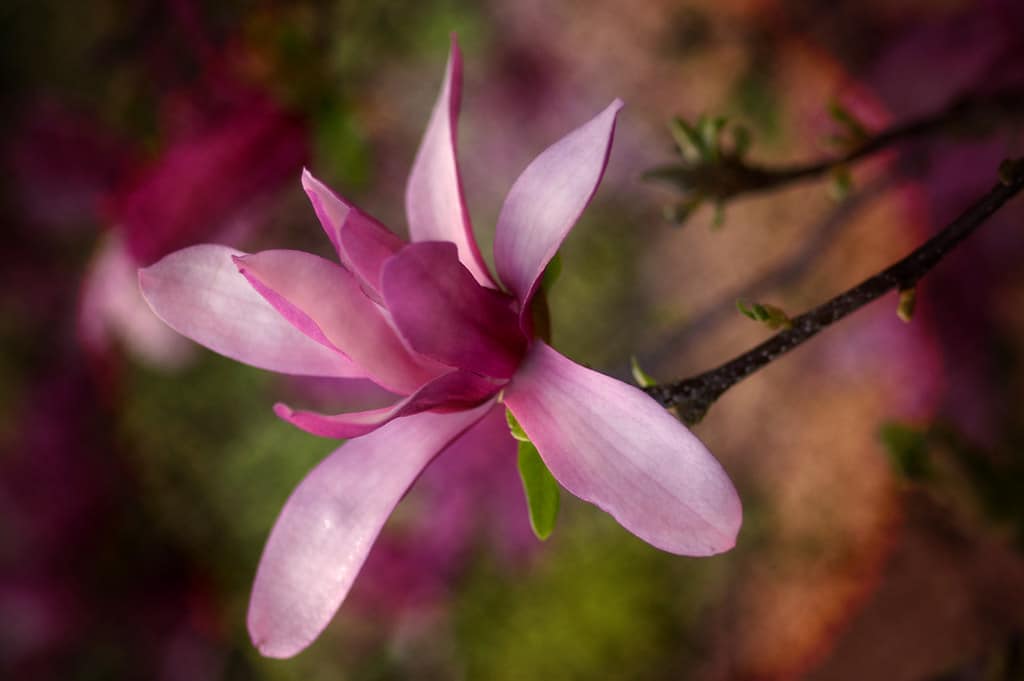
xmin=645 ymin=89 xmax=1024 ymax=204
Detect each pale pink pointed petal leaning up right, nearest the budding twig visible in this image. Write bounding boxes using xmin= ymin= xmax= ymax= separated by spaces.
xmin=495 ymin=99 xmax=623 ymax=318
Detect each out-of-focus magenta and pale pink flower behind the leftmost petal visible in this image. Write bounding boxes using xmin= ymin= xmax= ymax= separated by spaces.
xmin=78 ymin=95 xmax=306 ymax=367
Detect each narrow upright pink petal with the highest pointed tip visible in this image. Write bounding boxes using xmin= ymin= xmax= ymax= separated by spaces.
xmin=406 ymin=37 xmax=497 ymax=288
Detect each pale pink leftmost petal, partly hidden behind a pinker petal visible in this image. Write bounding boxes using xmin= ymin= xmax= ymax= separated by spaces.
xmin=138 ymin=245 xmax=365 ymax=377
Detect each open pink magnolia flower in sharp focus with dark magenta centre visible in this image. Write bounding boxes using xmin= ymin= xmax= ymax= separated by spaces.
xmin=139 ymin=43 xmax=741 ymax=657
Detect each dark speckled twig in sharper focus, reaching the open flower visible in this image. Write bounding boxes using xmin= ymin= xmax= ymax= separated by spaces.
xmin=645 ymin=159 xmax=1024 ymax=424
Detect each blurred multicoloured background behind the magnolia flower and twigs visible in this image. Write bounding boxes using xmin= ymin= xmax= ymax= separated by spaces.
xmin=0 ymin=0 xmax=1024 ymax=681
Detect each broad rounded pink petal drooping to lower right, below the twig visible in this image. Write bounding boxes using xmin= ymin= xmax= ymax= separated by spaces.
xmin=505 ymin=341 xmax=742 ymax=556
